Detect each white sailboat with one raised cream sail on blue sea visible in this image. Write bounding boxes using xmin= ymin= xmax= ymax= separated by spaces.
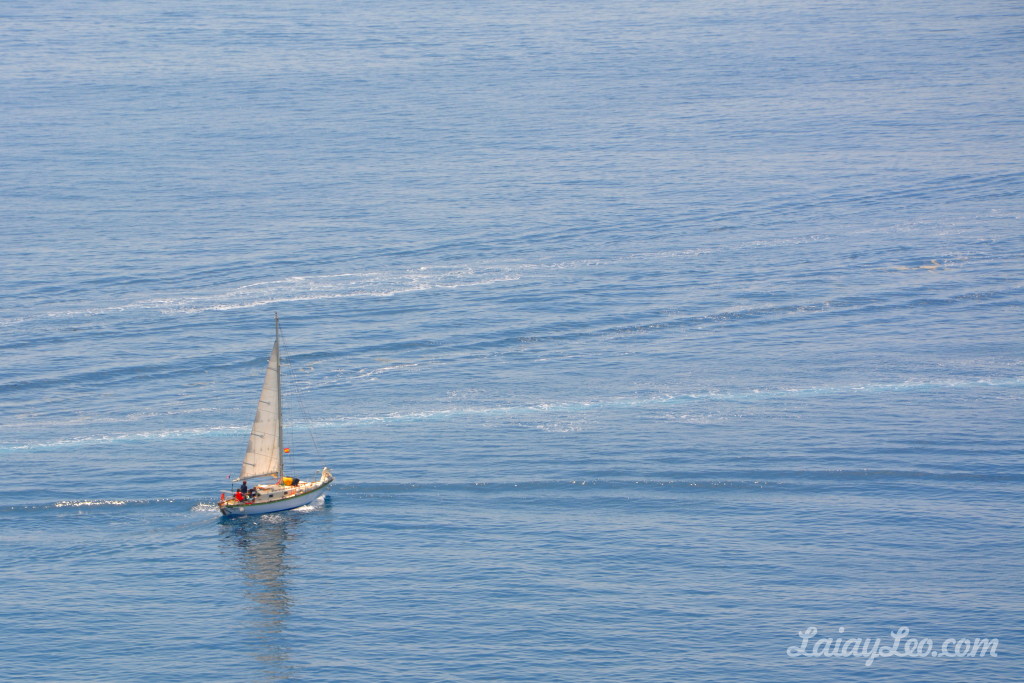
xmin=217 ymin=313 xmax=334 ymax=517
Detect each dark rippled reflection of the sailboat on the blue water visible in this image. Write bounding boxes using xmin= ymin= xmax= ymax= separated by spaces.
xmin=220 ymin=514 xmax=305 ymax=680
